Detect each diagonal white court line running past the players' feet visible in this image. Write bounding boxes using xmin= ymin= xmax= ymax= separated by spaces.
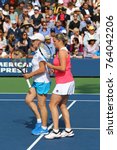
xmin=27 ymin=100 xmax=76 ymax=150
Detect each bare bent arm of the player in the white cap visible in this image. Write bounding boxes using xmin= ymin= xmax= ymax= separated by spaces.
xmin=24 ymin=61 xmax=46 ymax=79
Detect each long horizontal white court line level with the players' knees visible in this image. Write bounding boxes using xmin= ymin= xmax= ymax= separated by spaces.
xmin=0 ymin=99 xmax=100 ymax=102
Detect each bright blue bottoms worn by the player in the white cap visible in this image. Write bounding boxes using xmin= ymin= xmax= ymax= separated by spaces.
xmin=32 ymin=82 xmax=51 ymax=94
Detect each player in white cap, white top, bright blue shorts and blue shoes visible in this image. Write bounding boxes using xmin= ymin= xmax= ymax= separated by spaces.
xmin=24 ymin=33 xmax=50 ymax=135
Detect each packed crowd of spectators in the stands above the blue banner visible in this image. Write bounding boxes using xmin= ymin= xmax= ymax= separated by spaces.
xmin=0 ymin=0 xmax=100 ymax=59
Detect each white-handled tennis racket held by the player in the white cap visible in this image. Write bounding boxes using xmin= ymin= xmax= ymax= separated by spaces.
xmin=11 ymin=50 xmax=31 ymax=88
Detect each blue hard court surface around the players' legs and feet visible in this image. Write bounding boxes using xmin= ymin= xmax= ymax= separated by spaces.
xmin=0 ymin=94 xmax=100 ymax=150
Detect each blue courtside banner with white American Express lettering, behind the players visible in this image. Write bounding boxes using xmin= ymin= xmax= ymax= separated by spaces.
xmin=0 ymin=58 xmax=100 ymax=76
